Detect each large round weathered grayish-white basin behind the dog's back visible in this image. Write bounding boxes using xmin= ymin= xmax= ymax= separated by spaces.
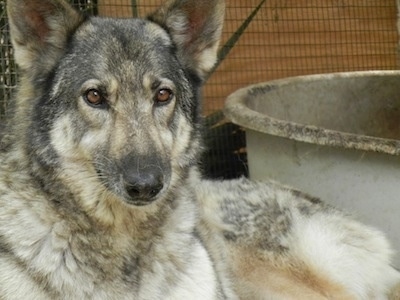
xmin=224 ymin=71 xmax=400 ymax=267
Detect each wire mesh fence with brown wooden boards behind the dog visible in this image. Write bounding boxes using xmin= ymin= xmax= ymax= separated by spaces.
xmin=0 ymin=0 xmax=400 ymax=178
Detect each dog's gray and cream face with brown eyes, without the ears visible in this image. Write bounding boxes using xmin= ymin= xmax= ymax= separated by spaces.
xmin=37 ymin=19 xmax=199 ymax=205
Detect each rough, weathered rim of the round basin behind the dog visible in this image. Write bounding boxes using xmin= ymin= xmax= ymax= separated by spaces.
xmin=223 ymin=70 xmax=400 ymax=155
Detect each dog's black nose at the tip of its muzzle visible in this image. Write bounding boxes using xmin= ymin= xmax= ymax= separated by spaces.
xmin=124 ymin=167 xmax=164 ymax=202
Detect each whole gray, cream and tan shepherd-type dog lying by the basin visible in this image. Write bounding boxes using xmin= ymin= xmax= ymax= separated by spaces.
xmin=0 ymin=0 xmax=400 ymax=300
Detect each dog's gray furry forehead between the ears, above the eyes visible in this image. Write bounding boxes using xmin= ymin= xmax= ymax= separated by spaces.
xmin=62 ymin=18 xmax=179 ymax=84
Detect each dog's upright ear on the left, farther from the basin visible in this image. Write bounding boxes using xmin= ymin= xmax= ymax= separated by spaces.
xmin=7 ymin=0 xmax=83 ymax=75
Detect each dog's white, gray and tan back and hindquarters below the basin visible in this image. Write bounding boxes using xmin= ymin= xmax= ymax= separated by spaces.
xmin=195 ymin=178 xmax=400 ymax=300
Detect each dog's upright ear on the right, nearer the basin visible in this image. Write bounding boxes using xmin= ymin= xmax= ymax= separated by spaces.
xmin=149 ymin=0 xmax=225 ymax=79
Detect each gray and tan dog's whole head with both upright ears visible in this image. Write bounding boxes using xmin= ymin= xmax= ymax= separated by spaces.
xmin=8 ymin=0 xmax=224 ymax=209
